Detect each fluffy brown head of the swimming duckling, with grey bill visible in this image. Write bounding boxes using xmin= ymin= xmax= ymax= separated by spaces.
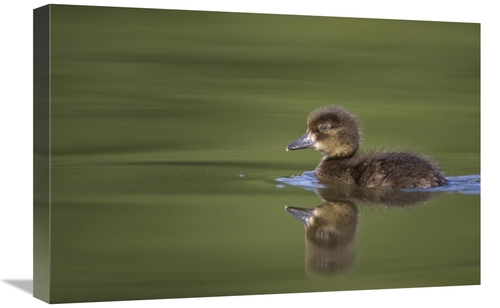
xmin=286 ymin=106 xmax=361 ymax=158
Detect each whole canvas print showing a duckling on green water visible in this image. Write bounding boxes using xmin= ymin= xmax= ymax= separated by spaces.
xmin=33 ymin=5 xmax=480 ymax=303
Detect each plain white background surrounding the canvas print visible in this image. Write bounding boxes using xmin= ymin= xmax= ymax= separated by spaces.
xmin=0 ymin=0 xmax=494 ymax=308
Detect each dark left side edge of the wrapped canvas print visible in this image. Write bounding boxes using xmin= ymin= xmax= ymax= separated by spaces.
xmin=33 ymin=5 xmax=50 ymax=302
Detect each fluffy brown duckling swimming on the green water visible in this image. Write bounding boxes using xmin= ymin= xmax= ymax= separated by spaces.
xmin=286 ymin=106 xmax=446 ymax=189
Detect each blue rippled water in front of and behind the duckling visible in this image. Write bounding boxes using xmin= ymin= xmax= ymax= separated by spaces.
xmin=276 ymin=171 xmax=481 ymax=195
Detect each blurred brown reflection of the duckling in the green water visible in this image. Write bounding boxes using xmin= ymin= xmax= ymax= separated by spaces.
xmin=285 ymin=183 xmax=435 ymax=276
